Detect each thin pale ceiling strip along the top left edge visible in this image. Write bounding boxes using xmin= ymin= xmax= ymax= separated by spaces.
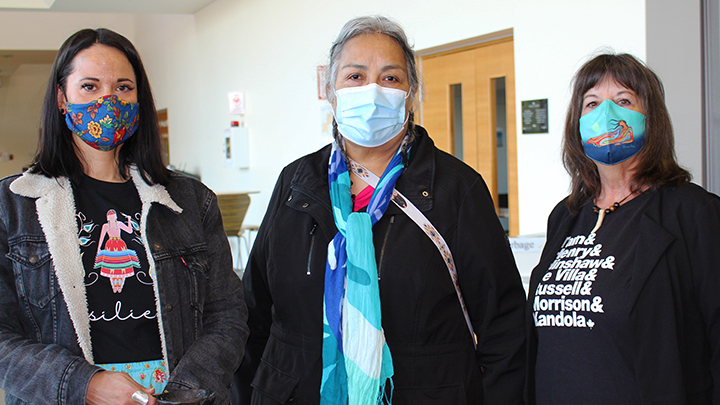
xmin=0 ymin=0 xmax=214 ymax=14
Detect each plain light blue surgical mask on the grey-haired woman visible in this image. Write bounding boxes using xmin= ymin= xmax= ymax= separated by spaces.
xmin=335 ymin=83 xmax=408 ymax=148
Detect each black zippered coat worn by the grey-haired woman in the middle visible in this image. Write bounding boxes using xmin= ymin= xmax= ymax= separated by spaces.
xmin=238 ymin=127 xmax=525 ymax=405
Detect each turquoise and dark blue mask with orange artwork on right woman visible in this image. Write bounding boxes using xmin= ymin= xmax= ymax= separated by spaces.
xmin=580 ymin=100 xmax=645 ymax=165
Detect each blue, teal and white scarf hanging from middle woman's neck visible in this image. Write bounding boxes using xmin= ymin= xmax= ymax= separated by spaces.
xmin=320 ymin=141 xmax=405 ymax=405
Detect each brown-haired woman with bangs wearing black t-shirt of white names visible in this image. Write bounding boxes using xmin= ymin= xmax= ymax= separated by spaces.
xmin=527 ymin=54 xmax=720 ymax=405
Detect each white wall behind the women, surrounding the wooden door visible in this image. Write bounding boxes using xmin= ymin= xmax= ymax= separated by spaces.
xmin=135 ymin=0 xmax=645 ymax=234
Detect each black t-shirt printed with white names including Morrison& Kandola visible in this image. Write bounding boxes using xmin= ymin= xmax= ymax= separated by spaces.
xmin=530 ymin=195 xmax=648 ymax=405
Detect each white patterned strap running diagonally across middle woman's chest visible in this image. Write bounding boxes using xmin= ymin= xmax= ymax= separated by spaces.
xmin=348 ymin=156 xmax=477 ymax=349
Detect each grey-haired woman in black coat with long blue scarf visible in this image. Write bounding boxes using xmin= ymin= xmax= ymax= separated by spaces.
xmin=233 ymin=17 xmax=525 ymax=405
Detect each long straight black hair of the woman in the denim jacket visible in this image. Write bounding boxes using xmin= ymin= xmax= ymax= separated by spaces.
xmin=30 ymin=28 xmax=170 ymax=184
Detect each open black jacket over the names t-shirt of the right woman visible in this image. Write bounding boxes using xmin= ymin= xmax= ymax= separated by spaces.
xmin=526 ymin=184 xmax=720 ymax=405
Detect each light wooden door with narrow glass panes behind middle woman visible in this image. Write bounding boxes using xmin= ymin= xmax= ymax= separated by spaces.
xmin=418 ymin=30 xmax=519 ymax=236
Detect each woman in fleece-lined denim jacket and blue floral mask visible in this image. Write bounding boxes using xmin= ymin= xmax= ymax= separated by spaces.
xmin=0 ymin=29 xmax=248 ymax=405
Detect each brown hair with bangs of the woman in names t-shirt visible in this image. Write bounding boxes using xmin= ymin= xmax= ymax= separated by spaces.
xmin=563 ymin=54 xmax=691 ymax=212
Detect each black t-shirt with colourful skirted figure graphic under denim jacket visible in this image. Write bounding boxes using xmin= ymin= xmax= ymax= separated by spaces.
xmin=73 ymin=176 xmax=162 ymax=364
